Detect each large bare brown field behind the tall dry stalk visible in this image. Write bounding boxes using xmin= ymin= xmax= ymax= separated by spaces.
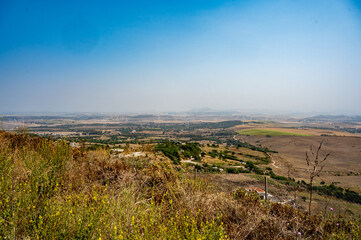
xmin=241 ymin=135 xmax=361 ymax=191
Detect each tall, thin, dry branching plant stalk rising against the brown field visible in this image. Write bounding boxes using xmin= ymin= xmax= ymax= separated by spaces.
xmin=306 ymin=141 xmax=330 ymax=215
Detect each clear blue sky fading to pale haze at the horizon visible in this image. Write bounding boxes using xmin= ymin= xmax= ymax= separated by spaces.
xmin=0 ymin=0 xmax=361 ymax=114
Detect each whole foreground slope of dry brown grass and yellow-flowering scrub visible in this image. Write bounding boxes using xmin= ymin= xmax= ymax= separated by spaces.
xmin=0 ymin=132 xmax=361 ymax=239
